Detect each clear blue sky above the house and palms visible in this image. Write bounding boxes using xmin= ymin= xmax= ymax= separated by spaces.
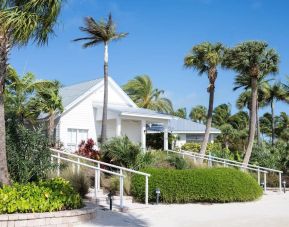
xmin=10 ymin=0 xmax=289 ymax=115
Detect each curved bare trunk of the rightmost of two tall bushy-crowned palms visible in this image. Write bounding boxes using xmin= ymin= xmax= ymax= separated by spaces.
xmin=243 ymin=77 xmax=258 ymax=166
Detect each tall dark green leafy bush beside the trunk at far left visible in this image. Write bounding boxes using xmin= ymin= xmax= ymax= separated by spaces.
xmin=6 ymin=123 xmax=53 ymax=183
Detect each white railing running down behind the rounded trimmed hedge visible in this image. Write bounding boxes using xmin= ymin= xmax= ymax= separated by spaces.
xmin=167 ymin=150 xmax=283 ymax=192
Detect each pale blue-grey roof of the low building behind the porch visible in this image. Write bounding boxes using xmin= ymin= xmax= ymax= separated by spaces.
xmin=147 ymin=117 xmax=221 ymax=134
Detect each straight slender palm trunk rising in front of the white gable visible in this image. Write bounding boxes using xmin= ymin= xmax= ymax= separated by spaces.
xmin=101 ymin=42 xmax=108 ymax=143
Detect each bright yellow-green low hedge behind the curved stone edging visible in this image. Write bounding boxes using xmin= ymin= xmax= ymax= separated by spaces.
xmin=0 ymin=178 xmax=82 ymax=214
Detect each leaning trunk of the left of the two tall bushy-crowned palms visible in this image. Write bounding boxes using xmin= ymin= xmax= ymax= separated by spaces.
xmin=200 ymin=79 xmax=215 ymax=155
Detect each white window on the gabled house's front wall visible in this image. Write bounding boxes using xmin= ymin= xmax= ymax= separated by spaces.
xmin=67 ymin=128 xmax=88 ymax=151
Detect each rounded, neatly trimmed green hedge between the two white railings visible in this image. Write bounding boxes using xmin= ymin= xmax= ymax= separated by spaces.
xmin=131 ymin=168 xmax=262 ymax=203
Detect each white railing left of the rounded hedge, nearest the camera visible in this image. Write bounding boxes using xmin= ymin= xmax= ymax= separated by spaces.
xmin=50 ymin=148 xmax=150 ymax=209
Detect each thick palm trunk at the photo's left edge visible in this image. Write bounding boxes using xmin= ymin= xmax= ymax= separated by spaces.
xmin=0 ymin=34 xmax=10 ymax=185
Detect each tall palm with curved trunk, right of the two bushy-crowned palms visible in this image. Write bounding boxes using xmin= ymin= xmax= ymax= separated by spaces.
xmin=223 ymin=41 xmax=279 ymax=165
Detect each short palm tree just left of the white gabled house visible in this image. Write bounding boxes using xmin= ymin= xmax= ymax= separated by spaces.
xmin=32 ymin=81 xmax=63 ymax=144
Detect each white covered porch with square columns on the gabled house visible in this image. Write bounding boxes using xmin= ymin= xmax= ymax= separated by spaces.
xmin=95 ymin=106 xmax=171 ymax=151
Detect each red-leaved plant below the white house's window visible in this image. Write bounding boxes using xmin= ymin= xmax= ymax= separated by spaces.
xmin=75 ymin=139 xmax=100 ymax=160
